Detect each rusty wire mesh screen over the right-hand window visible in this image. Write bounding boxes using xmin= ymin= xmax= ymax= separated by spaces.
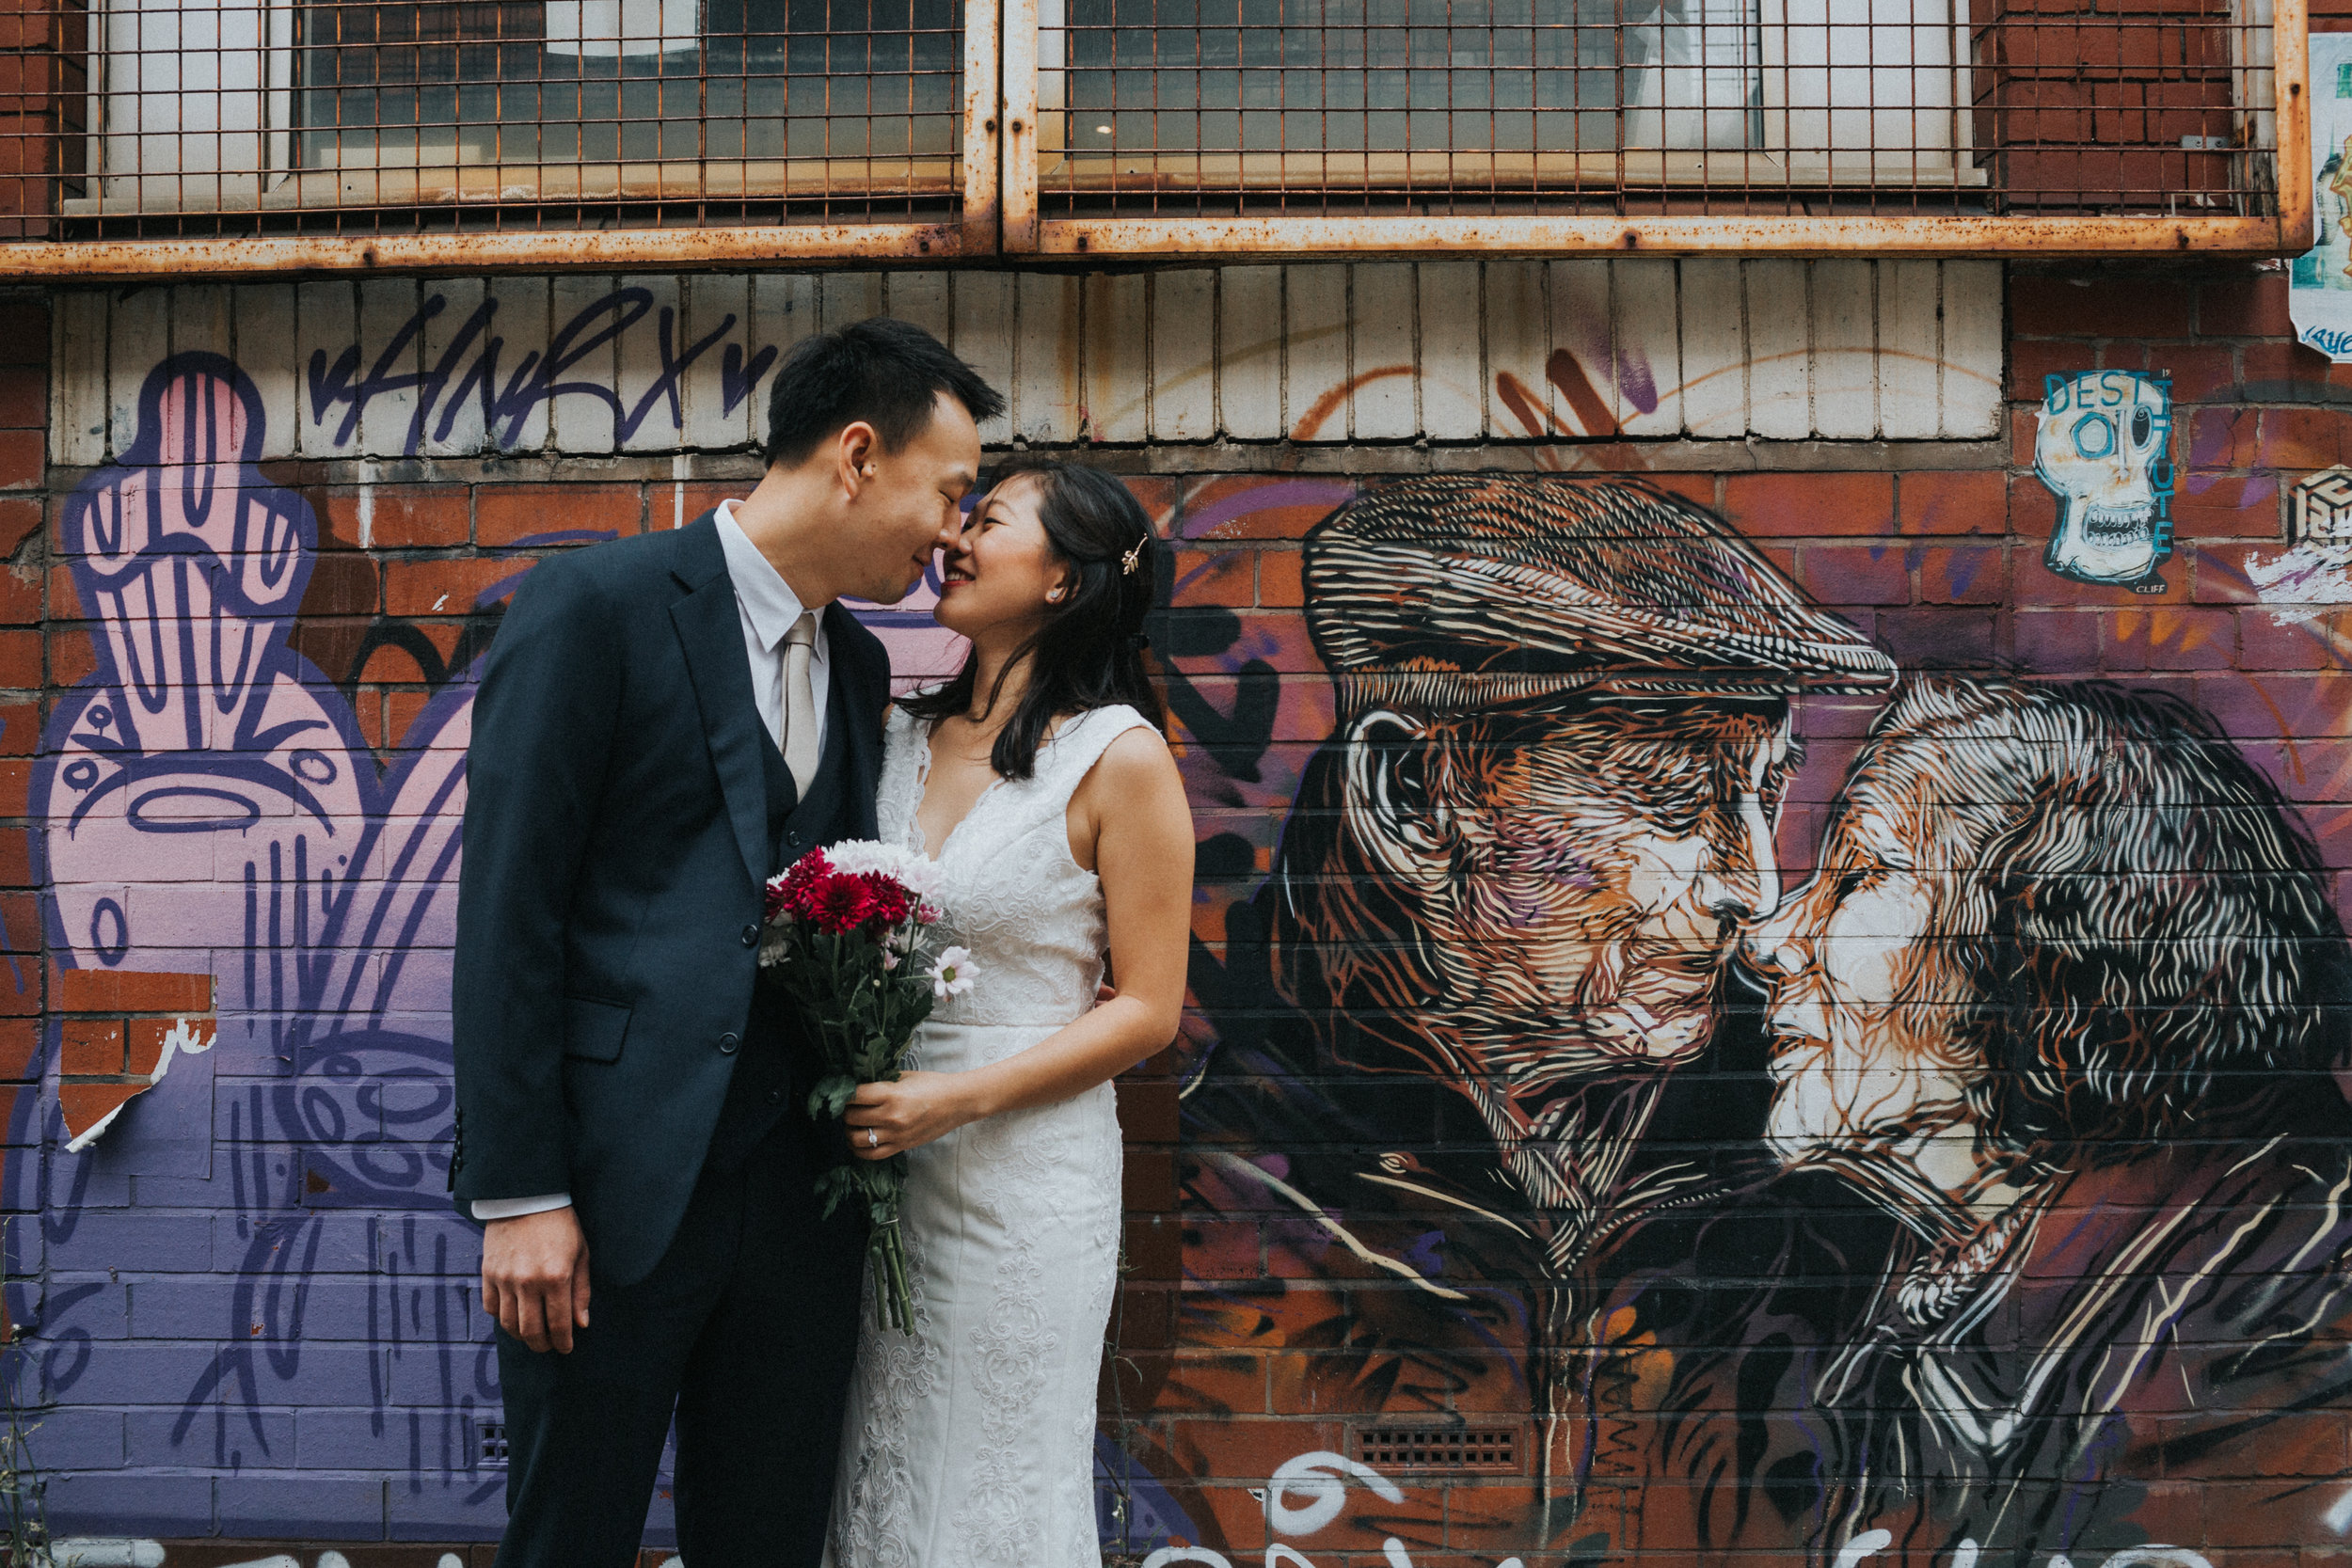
xmin=1038 ymin=0 xmax=2275 ymax=218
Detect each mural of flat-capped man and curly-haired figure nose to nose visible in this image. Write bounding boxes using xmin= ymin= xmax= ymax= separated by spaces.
xmin=1157 ymin=480 xmax=2352 ymax=1568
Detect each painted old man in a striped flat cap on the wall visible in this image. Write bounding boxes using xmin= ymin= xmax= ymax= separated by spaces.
xmin=1185 ymin=477 xmax=1894 ymax=1533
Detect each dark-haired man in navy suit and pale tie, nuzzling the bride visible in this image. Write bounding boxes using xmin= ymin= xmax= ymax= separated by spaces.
xmin=452 ymin=317 xmax=1002 ymax=1568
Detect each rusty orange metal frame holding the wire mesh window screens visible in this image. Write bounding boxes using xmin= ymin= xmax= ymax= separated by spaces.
xmin=0 ymin=0 xmax=2314 ymax=279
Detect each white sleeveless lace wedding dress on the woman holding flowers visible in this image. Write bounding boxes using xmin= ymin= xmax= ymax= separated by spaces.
xmin=826 ymin=707 xmax=1146 ymax=1568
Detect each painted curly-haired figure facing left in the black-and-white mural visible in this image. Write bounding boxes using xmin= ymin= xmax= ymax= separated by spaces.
xmin=1585 ymin=679 xmax=2352 ymax=1566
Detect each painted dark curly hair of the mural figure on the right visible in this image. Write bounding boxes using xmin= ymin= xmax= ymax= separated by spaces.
xmin=1856 ymin=679 xmax=2352 ymax=1164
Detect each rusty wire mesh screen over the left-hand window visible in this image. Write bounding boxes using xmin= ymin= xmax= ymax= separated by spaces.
xmin=0 ymin=0 xmax=964 ymax=237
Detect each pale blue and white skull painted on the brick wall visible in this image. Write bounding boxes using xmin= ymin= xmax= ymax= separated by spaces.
xmin=2035 ymin=369 xmax=2173 ymax=593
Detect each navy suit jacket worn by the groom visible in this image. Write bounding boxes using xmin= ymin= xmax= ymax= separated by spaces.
xmin=454 ymin=513 xmax=889 ymax=1286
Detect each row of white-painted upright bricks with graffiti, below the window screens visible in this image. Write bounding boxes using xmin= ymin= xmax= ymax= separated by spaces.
xmin=52 ymin=256 xmax=2002 ymax=466
